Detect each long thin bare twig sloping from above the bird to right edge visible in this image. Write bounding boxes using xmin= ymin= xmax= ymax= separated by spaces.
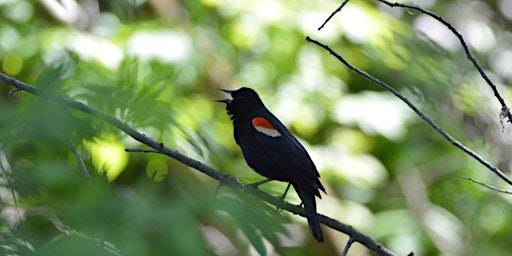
xmin=306 ymin=36 xmax=512 ymax=185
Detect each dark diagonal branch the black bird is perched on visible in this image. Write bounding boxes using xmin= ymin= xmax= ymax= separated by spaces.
xmin=0 ymin=72 xmax=395 ymax=256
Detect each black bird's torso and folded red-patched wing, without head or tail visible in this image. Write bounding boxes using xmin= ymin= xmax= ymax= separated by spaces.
xmin=232 ymin=108 xmax=324 ymax=196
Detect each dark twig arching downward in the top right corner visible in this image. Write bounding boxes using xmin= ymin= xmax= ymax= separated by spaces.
xmin=378 ymin=0 xmax=512 ymax=123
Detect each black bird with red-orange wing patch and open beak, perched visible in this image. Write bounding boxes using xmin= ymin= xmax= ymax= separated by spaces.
xmin=220 ymin=87 xmax=325 ymax=242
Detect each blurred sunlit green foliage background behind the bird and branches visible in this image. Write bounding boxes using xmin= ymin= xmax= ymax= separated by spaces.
xmin=0 ymin=0 xmax=512 ymax=255
